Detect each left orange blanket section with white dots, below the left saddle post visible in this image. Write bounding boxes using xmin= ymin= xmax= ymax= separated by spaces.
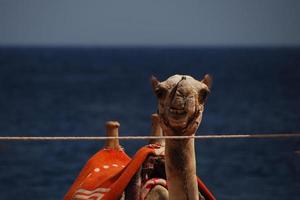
xmin=64 ymin=149 xmax=131 ymax=200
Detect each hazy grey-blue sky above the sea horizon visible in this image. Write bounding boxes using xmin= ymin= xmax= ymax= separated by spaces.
xmin=0 ymin=0 xmax=300 ymax=46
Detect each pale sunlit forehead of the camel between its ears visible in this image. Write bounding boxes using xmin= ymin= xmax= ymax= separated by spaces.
xmin=162 ymin=74 xmax=202 ymax=88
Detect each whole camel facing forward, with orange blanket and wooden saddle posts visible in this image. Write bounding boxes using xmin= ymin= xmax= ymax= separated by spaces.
xmin=64 ymin=75 xmax=215 ymax=200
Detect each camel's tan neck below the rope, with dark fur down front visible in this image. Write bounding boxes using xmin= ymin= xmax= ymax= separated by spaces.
xmin=165 ymin=139 xmax=199 ymax=200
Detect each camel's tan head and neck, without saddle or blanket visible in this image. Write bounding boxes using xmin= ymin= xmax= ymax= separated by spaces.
xmin=149 ymin=75 xmax=212 ymax=200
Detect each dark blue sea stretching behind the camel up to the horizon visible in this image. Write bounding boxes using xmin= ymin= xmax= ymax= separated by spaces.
xmin=0 ymin=48 xmax=300 ymax=200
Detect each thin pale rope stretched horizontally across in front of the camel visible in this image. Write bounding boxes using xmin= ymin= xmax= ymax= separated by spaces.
xmin=0 ymin=133 xmax=300 ymax=141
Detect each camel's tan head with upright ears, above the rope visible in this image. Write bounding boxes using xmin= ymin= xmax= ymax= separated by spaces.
xmin=151 ymin=75 xmax=212 ymax=135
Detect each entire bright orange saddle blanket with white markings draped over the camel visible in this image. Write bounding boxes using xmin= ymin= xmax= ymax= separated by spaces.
xmin=64 ymin=145 xmax=215 ymax=200
